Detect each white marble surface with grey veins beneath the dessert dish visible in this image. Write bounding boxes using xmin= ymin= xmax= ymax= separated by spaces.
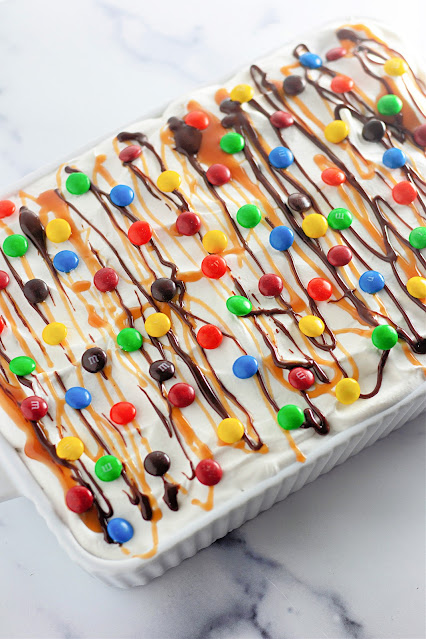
xmin=0 ymin=0 xmax=426 ymax=639
